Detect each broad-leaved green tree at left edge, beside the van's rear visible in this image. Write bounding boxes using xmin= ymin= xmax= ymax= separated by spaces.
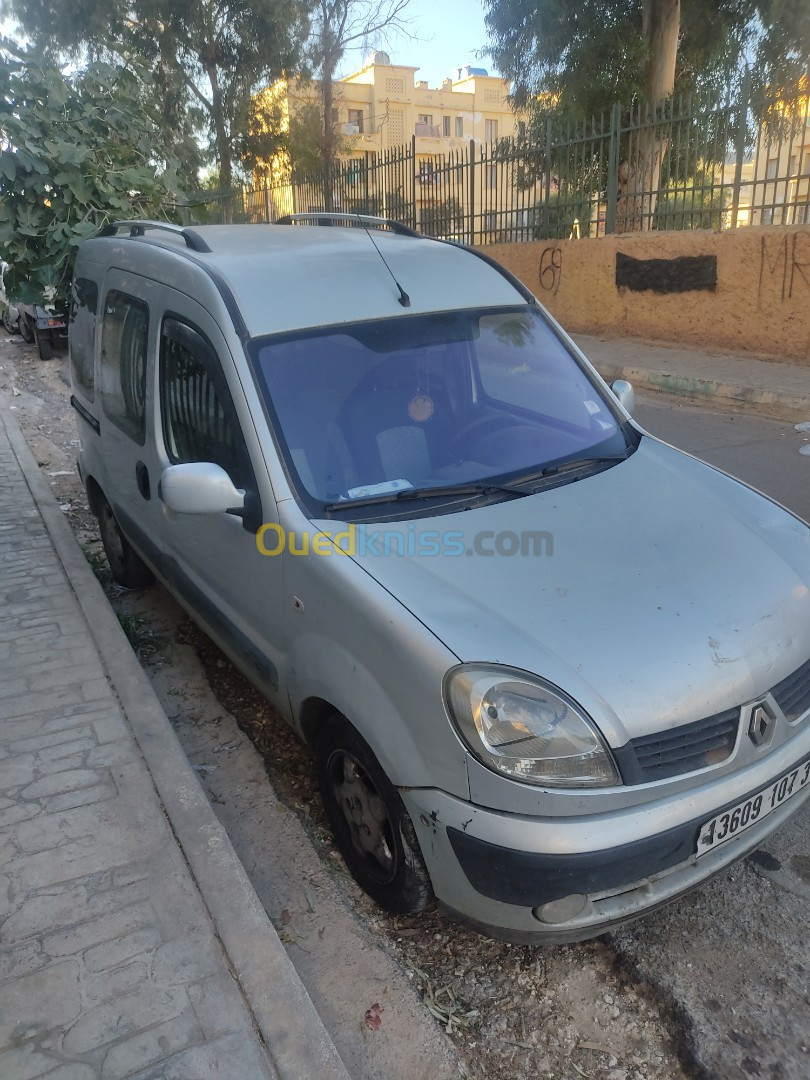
xmin=0 ymin=39 xmax=176 ymax=303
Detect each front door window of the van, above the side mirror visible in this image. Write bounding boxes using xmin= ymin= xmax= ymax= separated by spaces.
xmin=160 ymin=319 xmax=249 ymax=487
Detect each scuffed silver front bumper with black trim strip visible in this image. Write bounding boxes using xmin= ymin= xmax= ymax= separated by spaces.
xmin=402 ymin=739 xmax=810 ymax=943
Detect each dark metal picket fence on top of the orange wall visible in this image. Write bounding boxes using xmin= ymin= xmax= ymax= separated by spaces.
xmin=184 ymin=79 xmax=810 ymax=244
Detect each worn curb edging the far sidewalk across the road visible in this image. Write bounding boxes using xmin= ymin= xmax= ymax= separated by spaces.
xmin=591 ymin=357 xmax=810 ymax=422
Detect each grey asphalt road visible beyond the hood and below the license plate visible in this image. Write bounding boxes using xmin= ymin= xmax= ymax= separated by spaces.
xmin=612 ymin=397 xmax=810 ymax=1080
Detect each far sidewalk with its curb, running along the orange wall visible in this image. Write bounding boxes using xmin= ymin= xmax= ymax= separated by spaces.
xmin=572 ymin=334 xmax=810 ymax=422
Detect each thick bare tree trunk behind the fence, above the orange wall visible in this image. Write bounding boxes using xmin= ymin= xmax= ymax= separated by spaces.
xmin=616 ymin=0 xmax=680 ymax=232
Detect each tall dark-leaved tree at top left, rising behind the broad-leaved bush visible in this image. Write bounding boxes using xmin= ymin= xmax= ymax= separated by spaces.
xmin=8 ymin=0 xmax=308 ymax=188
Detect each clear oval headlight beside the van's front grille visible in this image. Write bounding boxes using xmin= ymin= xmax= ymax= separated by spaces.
xmin=445 ymin=666 xmax=620 ymax=787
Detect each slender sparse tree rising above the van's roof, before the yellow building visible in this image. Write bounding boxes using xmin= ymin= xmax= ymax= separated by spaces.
xmin=308 ymin=0 xmax=410 ymax=211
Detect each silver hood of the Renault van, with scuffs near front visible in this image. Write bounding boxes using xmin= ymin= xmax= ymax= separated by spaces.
xmin=329 ymin=436 xmax=810 ymax=746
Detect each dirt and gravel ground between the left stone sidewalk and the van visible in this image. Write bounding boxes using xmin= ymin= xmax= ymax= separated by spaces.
xmin=0 ymin=332 xmax=810 ymax=1080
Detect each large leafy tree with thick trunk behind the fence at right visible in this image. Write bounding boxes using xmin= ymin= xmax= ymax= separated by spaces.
xmin=486 ymin=0 xmax=810 ymax=231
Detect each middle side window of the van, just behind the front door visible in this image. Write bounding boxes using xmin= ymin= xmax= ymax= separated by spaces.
xmin=99 ymin=289 xmax=149 ymax=446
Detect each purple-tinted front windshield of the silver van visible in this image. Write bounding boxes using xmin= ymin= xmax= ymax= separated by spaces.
xmin=251 ymin=307 xmax=629 ymax=509
